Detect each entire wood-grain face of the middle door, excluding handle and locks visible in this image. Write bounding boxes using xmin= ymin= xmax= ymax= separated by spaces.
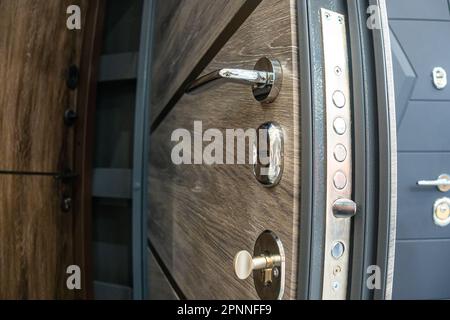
xmin=149 ymin=0 xmax=300 ymax=299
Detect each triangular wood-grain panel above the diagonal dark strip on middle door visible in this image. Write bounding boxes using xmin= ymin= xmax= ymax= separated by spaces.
xmin=152 ymin=0 xmax=250 ymax=124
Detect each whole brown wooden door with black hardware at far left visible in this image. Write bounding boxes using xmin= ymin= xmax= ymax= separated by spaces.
xmin=0 ymin=0 xmax=102 ymax=299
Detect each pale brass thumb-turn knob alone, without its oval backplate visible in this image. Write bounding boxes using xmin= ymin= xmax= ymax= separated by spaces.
xmin=233 ymin=250 xmax=281 ymax=280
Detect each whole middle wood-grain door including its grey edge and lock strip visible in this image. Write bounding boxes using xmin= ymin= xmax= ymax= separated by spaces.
xmin=148 ymin=0 xmax=396 ymax=299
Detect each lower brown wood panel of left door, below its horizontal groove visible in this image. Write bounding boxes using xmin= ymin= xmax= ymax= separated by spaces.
xmin=0 ymin=175 xmax=75 ymax=299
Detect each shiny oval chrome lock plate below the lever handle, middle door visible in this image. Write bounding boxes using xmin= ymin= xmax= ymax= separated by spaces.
xmin=253 ymin=122 xmax=284 ymax=187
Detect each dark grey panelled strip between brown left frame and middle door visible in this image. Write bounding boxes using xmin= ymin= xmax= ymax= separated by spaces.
xmin=93 ymin=0 xmax=146 ymax=299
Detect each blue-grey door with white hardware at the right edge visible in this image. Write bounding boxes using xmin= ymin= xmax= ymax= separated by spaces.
xmin=387 ymin=0 xmax=450 ymax=299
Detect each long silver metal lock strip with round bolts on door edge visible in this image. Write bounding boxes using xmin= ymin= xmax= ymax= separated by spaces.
xmin=321 ymin=8 xmax=356 ymax=300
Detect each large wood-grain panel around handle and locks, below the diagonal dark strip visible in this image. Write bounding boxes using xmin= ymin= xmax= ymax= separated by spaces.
xmin=149 ymin=0 xmax=301 ymax=299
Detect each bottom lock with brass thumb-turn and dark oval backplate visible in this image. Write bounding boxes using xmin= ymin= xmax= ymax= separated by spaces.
xmin=233 ymin=231 xmax=285 ymax=300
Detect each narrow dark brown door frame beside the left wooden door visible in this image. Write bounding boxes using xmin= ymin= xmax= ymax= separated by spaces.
xmin=73 ymin=0 xmax=106 ymax=299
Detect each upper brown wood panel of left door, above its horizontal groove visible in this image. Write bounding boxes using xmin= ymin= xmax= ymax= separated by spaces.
xmin=0 ymin=0 xmax=88 ymax=172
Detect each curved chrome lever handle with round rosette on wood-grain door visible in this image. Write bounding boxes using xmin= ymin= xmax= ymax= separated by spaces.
xmin=186 ymin=57 xmax=283 ymax=103
